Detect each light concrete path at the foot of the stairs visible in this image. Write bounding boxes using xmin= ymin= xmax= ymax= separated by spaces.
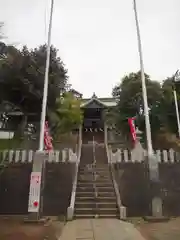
xmin=59 ymin=219 xmax=145 ymax=240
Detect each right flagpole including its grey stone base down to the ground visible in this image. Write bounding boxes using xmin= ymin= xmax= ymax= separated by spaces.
xmin=133 ymin=0 xmax=162 ymax=218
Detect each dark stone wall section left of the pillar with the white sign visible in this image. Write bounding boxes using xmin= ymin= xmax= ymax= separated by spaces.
xmin=0 ymin=163 xmax=32 ymax=215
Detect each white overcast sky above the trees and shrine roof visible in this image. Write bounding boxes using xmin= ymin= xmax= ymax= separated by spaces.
xmin=0 ymin=0 xmax=180 ymax=97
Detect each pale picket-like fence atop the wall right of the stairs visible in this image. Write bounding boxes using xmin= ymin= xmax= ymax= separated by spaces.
xmin=109 ymin=149 xmax=180 ymax=163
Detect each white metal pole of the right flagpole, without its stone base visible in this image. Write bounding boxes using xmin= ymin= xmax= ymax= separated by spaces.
xmin=133 ymin=0 xmax=153 ymax=157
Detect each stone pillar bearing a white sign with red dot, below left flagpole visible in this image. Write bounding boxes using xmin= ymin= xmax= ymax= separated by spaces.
xmin=28 ymin=151 xmax=48 ymax=221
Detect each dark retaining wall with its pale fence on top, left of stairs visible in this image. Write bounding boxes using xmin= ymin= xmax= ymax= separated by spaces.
xmin=0 ymin=149 xmax=77 ymax=216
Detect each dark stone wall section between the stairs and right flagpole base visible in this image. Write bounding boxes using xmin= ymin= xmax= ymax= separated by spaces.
xmin=114 ymin=163 xmax=151 ymax=217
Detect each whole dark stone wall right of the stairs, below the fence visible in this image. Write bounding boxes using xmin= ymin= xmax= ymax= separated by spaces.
xmin=115 ymin=162 xmax=180 ymax=217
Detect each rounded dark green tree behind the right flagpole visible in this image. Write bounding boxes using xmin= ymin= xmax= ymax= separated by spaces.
xmin=113 ymin=72 xmax=162 ymax=142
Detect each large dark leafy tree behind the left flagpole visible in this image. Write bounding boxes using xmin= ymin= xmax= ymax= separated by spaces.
xmin=0 ymin=45 xmax=69 ymax=134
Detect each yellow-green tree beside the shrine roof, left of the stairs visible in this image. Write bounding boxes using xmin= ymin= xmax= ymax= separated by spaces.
xmin=49 ymin=92 xmax=83 ymax=138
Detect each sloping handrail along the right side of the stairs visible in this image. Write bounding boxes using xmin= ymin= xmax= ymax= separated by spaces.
xmin=104 ymin=124 xmax=122 ymax=218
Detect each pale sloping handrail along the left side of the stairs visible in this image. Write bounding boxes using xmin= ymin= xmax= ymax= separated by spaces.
xmin=67 ymin=126 xmax=82 ymax=220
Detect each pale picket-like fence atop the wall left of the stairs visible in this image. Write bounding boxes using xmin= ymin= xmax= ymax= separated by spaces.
xmin=0 ymin=149 xmax=77 ymax=164
